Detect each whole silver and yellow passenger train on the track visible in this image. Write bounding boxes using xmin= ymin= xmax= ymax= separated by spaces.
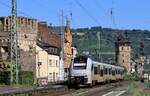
xmin=68 ymin=56 xmax=124 ymax=86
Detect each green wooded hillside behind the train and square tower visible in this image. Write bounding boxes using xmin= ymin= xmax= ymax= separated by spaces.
xmin=72 ymin=27 xmax=150 ymax=62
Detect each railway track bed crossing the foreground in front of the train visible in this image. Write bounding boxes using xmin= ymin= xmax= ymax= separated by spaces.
xmin=0 ymin=81 xmax=127 ymax=96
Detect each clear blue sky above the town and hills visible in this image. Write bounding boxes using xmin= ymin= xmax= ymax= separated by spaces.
xmin=0 ymin=0 xmax=150 ymax=30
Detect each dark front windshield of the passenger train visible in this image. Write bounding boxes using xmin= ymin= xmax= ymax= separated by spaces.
xmin=73 ymin=57 xmax=87 ymax=70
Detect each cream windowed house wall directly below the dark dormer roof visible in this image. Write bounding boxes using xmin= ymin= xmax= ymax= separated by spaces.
xmin=48 ymin=54 xmax=60 ymax=82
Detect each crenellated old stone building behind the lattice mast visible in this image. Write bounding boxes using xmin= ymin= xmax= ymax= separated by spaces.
xmin=0 ymin=16 xmax=38 ymax=72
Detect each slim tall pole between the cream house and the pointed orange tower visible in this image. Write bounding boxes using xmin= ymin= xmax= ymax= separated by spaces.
xmin=60 ymin=10 xmax=64 ymax=81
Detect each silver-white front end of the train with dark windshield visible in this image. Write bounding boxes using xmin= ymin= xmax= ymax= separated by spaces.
xmin=69 ymin=56 xmax=92 ymax=85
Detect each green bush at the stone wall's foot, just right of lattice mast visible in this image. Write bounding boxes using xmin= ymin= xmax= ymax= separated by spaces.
xmin=19 ymin=71 xmax=34 ymax=85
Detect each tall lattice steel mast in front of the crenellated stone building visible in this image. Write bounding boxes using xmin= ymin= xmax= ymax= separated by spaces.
xmin=10 ymin=0 xmax=18 ymax=84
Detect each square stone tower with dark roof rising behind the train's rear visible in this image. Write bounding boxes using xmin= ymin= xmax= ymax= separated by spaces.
xmin=115 ymin=34 xmax=131 ymax=72
